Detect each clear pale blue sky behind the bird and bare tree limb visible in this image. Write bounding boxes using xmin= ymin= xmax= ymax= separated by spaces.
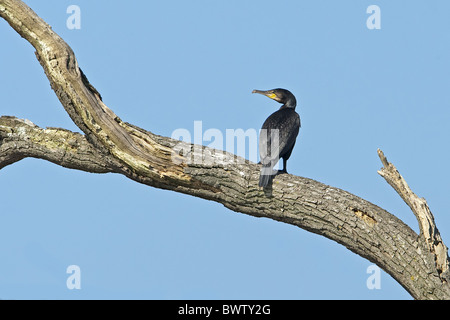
xmin=0 ymin=0 xmax=450 ymax=299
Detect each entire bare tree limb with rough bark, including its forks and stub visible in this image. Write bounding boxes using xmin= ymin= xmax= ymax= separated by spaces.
xmin=0 ymin=0 xmax=450 ymax=299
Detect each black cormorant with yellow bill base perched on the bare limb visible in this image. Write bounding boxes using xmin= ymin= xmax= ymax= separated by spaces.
xmin=252 ymin=89 xmax=300 ymax=188
